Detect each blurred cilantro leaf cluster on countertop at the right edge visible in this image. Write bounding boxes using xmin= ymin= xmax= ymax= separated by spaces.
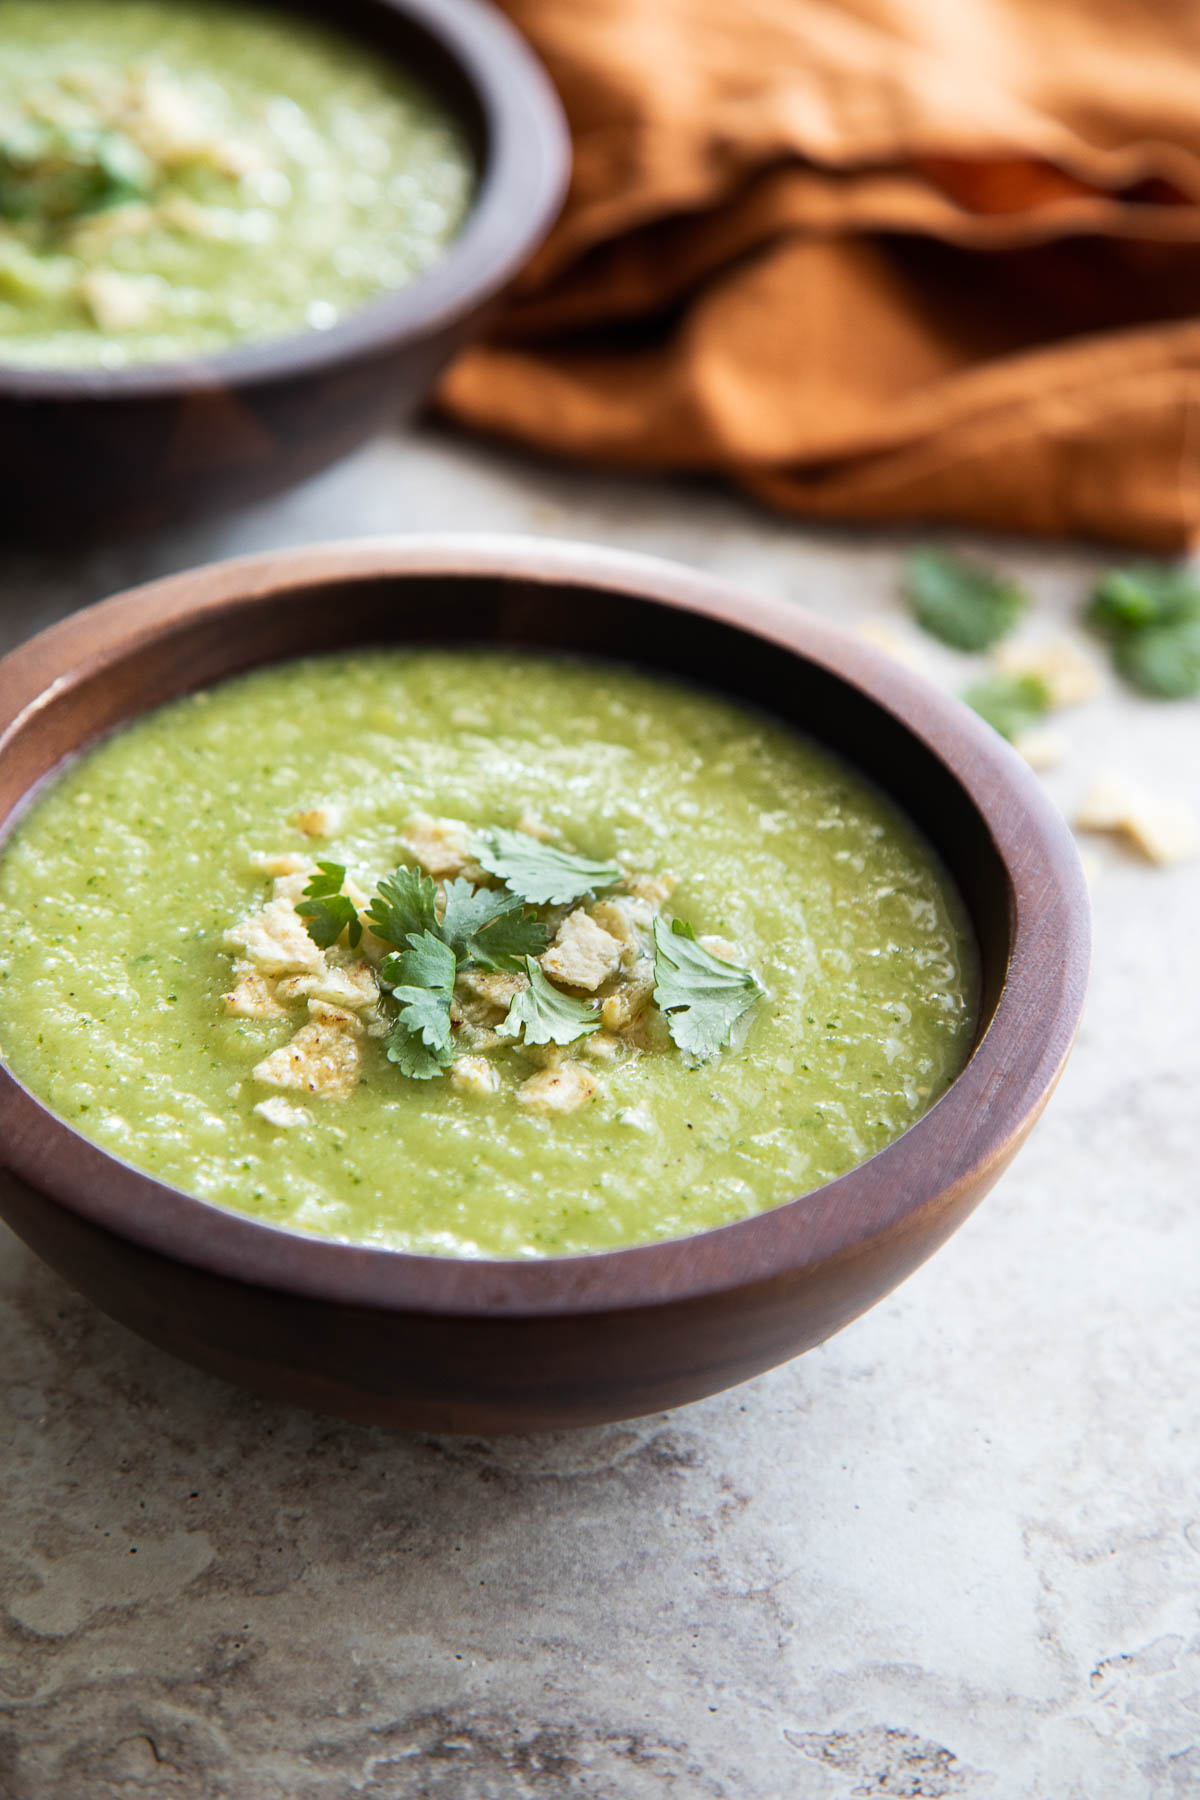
xmin=1085 ymin=563 xmax=1200 ymax=700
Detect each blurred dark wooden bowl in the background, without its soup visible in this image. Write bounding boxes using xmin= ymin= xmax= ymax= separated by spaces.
xmin=0 ymin=0 xmax=570 ymax=544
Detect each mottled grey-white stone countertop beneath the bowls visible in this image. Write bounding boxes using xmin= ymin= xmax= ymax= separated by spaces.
xmin=0 ymin=432 xmax=1200 ymax=1800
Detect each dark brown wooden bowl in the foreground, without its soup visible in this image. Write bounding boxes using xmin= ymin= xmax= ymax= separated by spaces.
xmin=0 ymin=538 xmax=1088 ymax=1433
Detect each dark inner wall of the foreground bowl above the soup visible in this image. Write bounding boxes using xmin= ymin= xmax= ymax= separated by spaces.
xmin=0 ymin=574 xmax=1013 ymax=1033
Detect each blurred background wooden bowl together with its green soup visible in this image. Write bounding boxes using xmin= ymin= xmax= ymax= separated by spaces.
xmin=0 ymin=0 xmax=570 ymax=545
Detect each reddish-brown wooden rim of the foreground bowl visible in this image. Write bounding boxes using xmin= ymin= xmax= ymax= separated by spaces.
xmin=0 ymin=536 xmax=1088 ymax=1318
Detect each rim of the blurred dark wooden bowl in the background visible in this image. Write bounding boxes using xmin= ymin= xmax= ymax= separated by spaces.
xmin=0 ymin=0 xmax=570 ymax=401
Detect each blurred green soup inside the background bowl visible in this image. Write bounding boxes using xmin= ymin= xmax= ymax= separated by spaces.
xmin=0 ymin=0 xmax=473 ymax=369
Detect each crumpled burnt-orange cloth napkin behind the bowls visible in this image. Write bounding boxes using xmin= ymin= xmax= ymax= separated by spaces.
xmin=441 ymin=0 xmax=1200 ymax=549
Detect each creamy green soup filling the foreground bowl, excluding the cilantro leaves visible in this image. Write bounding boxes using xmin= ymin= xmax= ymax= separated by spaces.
xmin=0 ymin=652 xmax=975 ymax=1258
